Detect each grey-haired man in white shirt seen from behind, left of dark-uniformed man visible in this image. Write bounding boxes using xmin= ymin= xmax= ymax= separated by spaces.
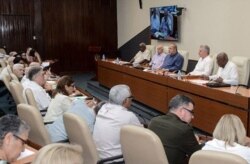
xmin=93 ymin=85 xmax=142 ymax=159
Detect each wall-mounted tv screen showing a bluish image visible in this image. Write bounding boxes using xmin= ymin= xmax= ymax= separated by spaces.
xmin=150 ymin=5 xmax=178 ymax=40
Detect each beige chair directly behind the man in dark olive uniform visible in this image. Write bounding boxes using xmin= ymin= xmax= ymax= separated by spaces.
xmin=121 ymin=125 xmax=168 ymax=164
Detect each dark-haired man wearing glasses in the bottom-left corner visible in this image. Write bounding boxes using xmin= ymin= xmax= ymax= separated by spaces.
xmin=0 ymin=115 xmax=30 ymax=163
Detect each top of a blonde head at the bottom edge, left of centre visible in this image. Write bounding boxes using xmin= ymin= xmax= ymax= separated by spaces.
xmin=32 ymin=143 xmax=83 ymax=164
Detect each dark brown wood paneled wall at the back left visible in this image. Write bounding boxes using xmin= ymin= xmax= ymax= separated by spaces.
xmin=0 ymin=0 xmax=117 ymax=72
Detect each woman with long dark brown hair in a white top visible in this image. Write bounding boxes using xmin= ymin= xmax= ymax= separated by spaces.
xmin=44 ymin=76 xmax=75 ymax=122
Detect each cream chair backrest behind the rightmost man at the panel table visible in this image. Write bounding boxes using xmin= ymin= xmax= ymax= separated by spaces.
xmin=231 ymin=56 xmax=250 ymax=85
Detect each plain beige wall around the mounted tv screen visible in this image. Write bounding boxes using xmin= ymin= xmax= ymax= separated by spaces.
xmin=117 ymin=0 xmax=250 ymax=60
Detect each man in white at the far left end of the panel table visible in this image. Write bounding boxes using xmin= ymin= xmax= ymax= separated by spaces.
xmin=130 ymin=43 xmax=151 ymax=64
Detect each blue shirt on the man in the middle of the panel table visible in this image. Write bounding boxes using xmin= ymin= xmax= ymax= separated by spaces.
xmin=161 ymin=52 xmax=184 ymax=72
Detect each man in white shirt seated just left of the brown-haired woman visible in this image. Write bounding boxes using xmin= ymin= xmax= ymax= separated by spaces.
xmin=22 ymin=67 xmax=51 ymax=116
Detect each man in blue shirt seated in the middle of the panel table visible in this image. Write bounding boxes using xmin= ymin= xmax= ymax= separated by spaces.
xmin=161 ymin=43 xmax=184 ymax=72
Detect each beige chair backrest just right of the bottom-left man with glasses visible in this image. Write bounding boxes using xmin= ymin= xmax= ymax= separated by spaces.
xmin=17 ymin=104 xmax=51 ymax=146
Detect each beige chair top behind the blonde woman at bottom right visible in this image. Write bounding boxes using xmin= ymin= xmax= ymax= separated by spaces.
xmin=189 ymin=150 xmax=247 ymax=164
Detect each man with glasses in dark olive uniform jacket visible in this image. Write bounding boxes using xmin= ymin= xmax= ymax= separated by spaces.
xmin=148 ymin=95 xmax=201 ymax=164
